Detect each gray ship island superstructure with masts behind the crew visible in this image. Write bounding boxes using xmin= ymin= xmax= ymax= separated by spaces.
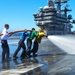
xmin=33 ymin=0 xmax=75 ymax=35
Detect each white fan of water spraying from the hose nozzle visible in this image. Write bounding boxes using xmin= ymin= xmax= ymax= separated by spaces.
xmin=48 ymin=35 xmax=75 ymax=54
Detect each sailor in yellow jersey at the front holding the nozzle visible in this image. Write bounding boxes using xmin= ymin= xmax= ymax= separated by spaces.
xmin=30 ymin=28 xmax=47 ymax=57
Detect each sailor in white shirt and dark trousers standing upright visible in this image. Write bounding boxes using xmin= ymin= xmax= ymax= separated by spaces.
xmin=1 ymin=24 xmax=13 ymax=61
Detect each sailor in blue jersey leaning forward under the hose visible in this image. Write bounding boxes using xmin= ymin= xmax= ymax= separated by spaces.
xmin=13 ymin=29 xmax=30 ymax=59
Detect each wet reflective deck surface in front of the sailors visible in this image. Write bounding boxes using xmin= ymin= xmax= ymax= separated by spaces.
xmin=0 ymin=34 xmax=75 ymax=75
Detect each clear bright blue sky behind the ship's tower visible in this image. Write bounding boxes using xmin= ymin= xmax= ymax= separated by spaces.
xmin=0 ymin=0 xmax=75 ymax=31
